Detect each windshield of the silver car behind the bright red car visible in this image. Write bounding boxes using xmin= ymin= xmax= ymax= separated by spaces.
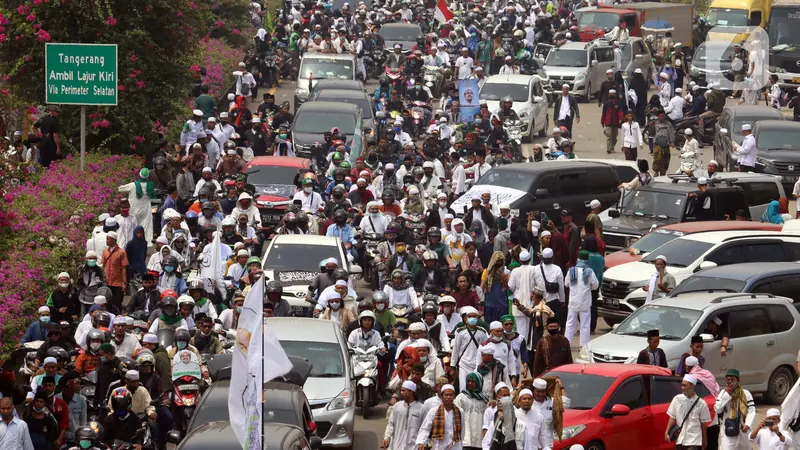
xmin=613 ymin=304 xmax=703 ymax=340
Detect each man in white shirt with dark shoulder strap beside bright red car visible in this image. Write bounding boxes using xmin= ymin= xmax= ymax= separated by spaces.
xmin=664 ymin=375 xmax=711 ymax=448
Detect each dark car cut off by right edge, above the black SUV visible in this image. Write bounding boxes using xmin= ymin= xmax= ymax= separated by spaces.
xmin=753 ymin=120 xmax=800 ymax=192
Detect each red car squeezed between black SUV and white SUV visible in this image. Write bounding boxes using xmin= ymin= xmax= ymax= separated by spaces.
xmin=605 ymin=220 xmax=783 ymax=269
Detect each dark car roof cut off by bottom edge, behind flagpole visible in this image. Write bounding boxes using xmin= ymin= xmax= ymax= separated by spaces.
xmin=171 ymin=420 xmax=322 ymax=450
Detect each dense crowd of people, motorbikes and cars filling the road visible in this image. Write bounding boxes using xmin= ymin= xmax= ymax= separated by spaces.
xmin=0 ymin=0 xmax=800 ymax=450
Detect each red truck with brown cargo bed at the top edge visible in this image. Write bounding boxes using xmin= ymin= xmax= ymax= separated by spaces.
xmin=576 ymin=2 xmax=694 ymax=47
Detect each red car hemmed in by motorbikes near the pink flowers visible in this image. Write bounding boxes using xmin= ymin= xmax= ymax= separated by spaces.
xmin=243 ymin=156 xmax=311 ymax=232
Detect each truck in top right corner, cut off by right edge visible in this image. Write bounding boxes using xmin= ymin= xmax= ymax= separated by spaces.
xmin=766 ymin=0 xmax=800 ymax=91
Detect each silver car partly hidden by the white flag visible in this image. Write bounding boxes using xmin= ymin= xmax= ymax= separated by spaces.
xmin=266 ymin=317 xmax=355 ymax=448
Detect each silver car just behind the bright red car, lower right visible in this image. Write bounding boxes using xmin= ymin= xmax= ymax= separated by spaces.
xmin=575 ymin=292 xmax=800 ymax=404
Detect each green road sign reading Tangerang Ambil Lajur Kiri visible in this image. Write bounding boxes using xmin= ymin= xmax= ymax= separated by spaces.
xmin=44 ymin=43 xmax=118 ymax=105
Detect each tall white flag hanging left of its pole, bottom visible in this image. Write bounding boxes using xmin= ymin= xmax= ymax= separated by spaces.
xmin=228 ymin=280 xmax=266 ymax=450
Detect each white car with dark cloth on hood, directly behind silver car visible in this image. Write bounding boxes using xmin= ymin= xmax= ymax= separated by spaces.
xmin=263 ymin=234 xmax=361 ymax=317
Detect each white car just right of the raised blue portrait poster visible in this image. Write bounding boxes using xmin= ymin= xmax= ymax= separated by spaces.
xmin=479 ymin=75 xmax=550 ymax=141
